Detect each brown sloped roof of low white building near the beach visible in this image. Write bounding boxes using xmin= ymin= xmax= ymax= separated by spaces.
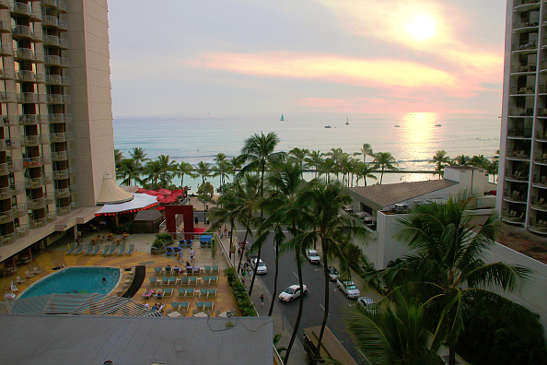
xmin=350 ymin=179 xmax=458 ymax=209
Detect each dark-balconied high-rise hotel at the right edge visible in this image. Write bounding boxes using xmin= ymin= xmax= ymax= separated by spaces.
xmin=497 ymin=0 xmax=547 ymax=235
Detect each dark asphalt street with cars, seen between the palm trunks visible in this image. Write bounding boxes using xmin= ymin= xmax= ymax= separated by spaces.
xmin=247 ymin=232 xmax=366 ymax=364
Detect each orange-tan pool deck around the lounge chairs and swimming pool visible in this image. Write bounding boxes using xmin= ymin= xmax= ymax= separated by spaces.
xmin=0 ymin=230 xmax=238 ymax=317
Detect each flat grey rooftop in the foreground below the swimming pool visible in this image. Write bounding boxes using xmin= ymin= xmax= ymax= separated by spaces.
xmin=0 ymin=315 xmax=273 ymax=365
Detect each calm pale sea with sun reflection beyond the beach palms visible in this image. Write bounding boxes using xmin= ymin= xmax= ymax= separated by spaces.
xmin=113 ymin=113 xmax=500 ymax=189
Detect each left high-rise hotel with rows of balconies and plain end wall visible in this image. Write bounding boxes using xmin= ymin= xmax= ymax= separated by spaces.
xmin=0 ymin=0 xmax=114 ymax=261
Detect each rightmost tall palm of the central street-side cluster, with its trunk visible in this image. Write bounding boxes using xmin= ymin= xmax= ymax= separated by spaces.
xmin=303 ymin=181 xmax=367 ymax=356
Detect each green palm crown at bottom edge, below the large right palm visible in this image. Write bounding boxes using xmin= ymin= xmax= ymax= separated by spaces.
xmin=348 ymin=295 xmax=444 ymax=365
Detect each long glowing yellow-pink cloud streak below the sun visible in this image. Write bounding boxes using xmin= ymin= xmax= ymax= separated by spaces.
xmin=186 ymin=53 xmax=457 ymax=89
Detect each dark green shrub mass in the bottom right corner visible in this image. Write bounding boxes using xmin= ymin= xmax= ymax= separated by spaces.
xmin=456 ymin=293 xmax=547 ymax=365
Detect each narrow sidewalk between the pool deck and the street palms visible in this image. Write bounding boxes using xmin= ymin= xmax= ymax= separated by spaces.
xmin=219 ymin=232 xmax=307 ymax=365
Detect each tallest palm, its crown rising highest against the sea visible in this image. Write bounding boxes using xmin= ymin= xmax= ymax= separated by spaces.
xmin=241 ymin=133 xmax=279 ymax=295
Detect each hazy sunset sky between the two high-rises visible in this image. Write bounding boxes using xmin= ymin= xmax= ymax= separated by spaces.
xmin=109 ymin=0 xmax=505 ymax=118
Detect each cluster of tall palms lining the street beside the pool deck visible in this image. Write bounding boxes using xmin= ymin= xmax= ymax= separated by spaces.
xmin=210 ymin=133 xmax=366 ymax=364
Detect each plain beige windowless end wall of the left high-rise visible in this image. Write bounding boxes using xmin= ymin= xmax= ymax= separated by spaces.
xmin=68 ymin=0 xmax=114 ymax=206
